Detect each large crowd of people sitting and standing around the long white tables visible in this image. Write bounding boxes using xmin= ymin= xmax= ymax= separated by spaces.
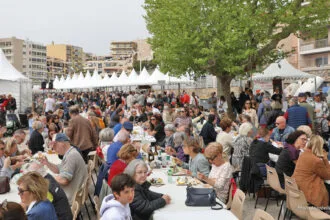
xmin=0 ymin=88 xmax=330 ymax=220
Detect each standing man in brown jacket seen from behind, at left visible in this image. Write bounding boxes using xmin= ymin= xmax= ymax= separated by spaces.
xmin=65 ymin=106 xmax=98 ymax=163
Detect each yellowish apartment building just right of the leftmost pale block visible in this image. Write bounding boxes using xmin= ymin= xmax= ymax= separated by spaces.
xmin=47 ymin=42 xmax=84 ymax=74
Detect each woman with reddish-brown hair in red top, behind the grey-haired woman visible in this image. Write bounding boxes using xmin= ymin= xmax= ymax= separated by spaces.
xmin=108 ymin=144 xmax=139 ymax=186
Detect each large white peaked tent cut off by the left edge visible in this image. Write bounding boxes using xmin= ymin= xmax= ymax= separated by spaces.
xmin=0 ymin=49 xmax=32 ymax=112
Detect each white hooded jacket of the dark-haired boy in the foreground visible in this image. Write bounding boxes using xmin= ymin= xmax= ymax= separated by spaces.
xmin=100 ymin=194 xmax=132 ymax=220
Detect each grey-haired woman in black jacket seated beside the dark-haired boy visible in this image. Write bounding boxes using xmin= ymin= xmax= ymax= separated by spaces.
xmin=124 ymin=159 xmax=171 ymax=220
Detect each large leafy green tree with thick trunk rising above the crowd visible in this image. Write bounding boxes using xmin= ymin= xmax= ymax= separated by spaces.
xmin=144 ymin=0 xmax=330 ymax=118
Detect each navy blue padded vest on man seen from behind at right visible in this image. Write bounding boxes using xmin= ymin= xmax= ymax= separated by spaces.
xmin=284 ymin=105 xmax=311 ymax=129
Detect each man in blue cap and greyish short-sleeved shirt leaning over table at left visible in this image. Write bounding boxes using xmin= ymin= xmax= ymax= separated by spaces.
xmin=39 ymin=133 xmax=87 ymax=205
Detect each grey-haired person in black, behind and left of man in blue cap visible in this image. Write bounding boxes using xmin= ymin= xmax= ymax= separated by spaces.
xmin=29 ymin=121 xmax=45 ymax=154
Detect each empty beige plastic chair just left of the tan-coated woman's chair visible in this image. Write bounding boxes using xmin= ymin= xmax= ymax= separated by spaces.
xmin=265 ymin=165 xmax=286 ymax=219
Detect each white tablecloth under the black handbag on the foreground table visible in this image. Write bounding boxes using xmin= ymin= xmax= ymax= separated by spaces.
xmin=149 ymin=169 xmax=237 ymax=220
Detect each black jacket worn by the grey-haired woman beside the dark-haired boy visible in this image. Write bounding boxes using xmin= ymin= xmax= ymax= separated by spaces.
xmin=130 ymin=182 xmax=166 ymax=220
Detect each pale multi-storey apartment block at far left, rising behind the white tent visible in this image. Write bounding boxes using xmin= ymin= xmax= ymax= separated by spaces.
xmin=0 ymin=37 xmax=47 ymax=85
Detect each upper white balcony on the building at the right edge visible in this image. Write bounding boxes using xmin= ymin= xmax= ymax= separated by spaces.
xmin=300 ymin=38 xmax=330 ymax=55
